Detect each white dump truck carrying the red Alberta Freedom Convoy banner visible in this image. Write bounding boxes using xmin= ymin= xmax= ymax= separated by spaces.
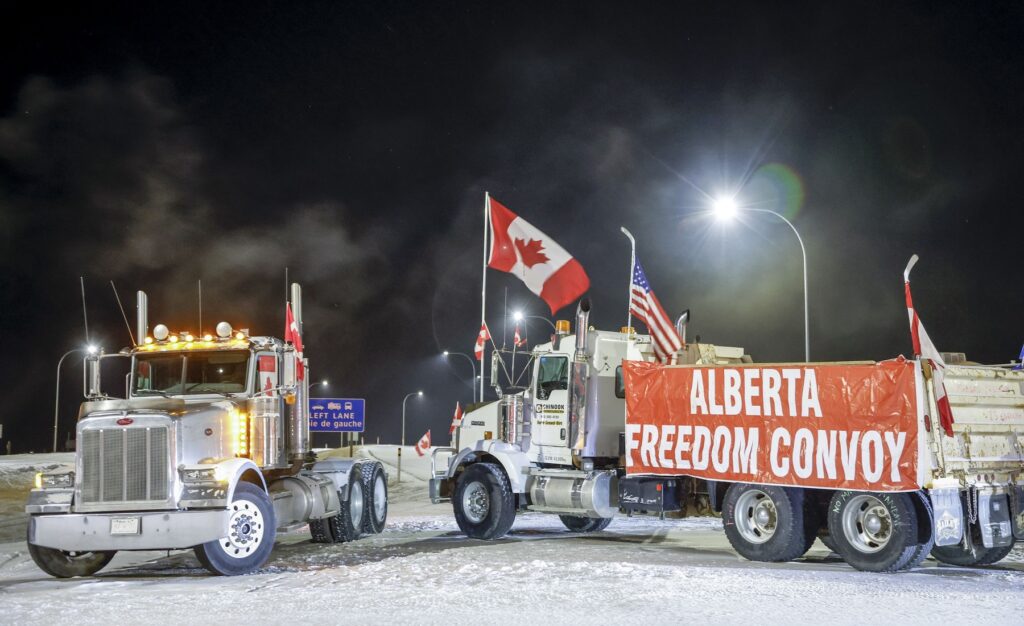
xmin=429 ymin=301 xmax=1024 ymax=572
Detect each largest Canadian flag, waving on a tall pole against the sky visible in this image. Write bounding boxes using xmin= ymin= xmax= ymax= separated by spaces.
xmin=487 ymin=196 xmax=590 ymax=315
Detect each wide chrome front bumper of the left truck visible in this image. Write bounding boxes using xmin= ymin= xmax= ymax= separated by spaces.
xmin=29 ymin=509 xmax=228 ymax=551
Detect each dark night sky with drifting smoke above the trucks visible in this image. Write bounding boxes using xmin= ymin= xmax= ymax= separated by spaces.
xmin=0 ymin=0 xmax=1024 ymax=452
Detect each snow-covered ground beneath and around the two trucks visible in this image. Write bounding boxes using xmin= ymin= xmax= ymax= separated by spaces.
xmin=0 ymin=446 xmax=1024 ymax=624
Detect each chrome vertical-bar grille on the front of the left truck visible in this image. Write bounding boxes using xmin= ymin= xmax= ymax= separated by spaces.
xmin=80 ymin=426 xmax=169 ymax=504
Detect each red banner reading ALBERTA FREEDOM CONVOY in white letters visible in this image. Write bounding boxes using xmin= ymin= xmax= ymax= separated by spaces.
xmin=623 ymin=360 xmax=919 ymax=491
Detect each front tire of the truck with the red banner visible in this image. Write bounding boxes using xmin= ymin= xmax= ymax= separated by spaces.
xmin=452 ymin=463 xmax=515 ymax=540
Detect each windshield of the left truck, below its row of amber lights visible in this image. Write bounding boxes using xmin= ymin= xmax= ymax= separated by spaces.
xmin=132 ymin=350 xmax=249 ymax=395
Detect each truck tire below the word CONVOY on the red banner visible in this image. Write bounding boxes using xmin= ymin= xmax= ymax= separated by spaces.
xmin=828 ymin=491 xmax=919 ymax=572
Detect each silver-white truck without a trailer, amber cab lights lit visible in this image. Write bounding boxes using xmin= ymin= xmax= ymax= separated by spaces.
xmin=26 ymin=284 xmax=387 ymax=578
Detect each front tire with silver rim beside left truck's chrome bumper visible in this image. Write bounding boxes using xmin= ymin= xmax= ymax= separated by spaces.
xmin=195 ymin=483 xmax=278 ymax=576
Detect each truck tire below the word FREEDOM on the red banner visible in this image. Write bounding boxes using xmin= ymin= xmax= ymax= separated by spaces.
xmin=722 ymin=483 xmax=807 ymax=561
